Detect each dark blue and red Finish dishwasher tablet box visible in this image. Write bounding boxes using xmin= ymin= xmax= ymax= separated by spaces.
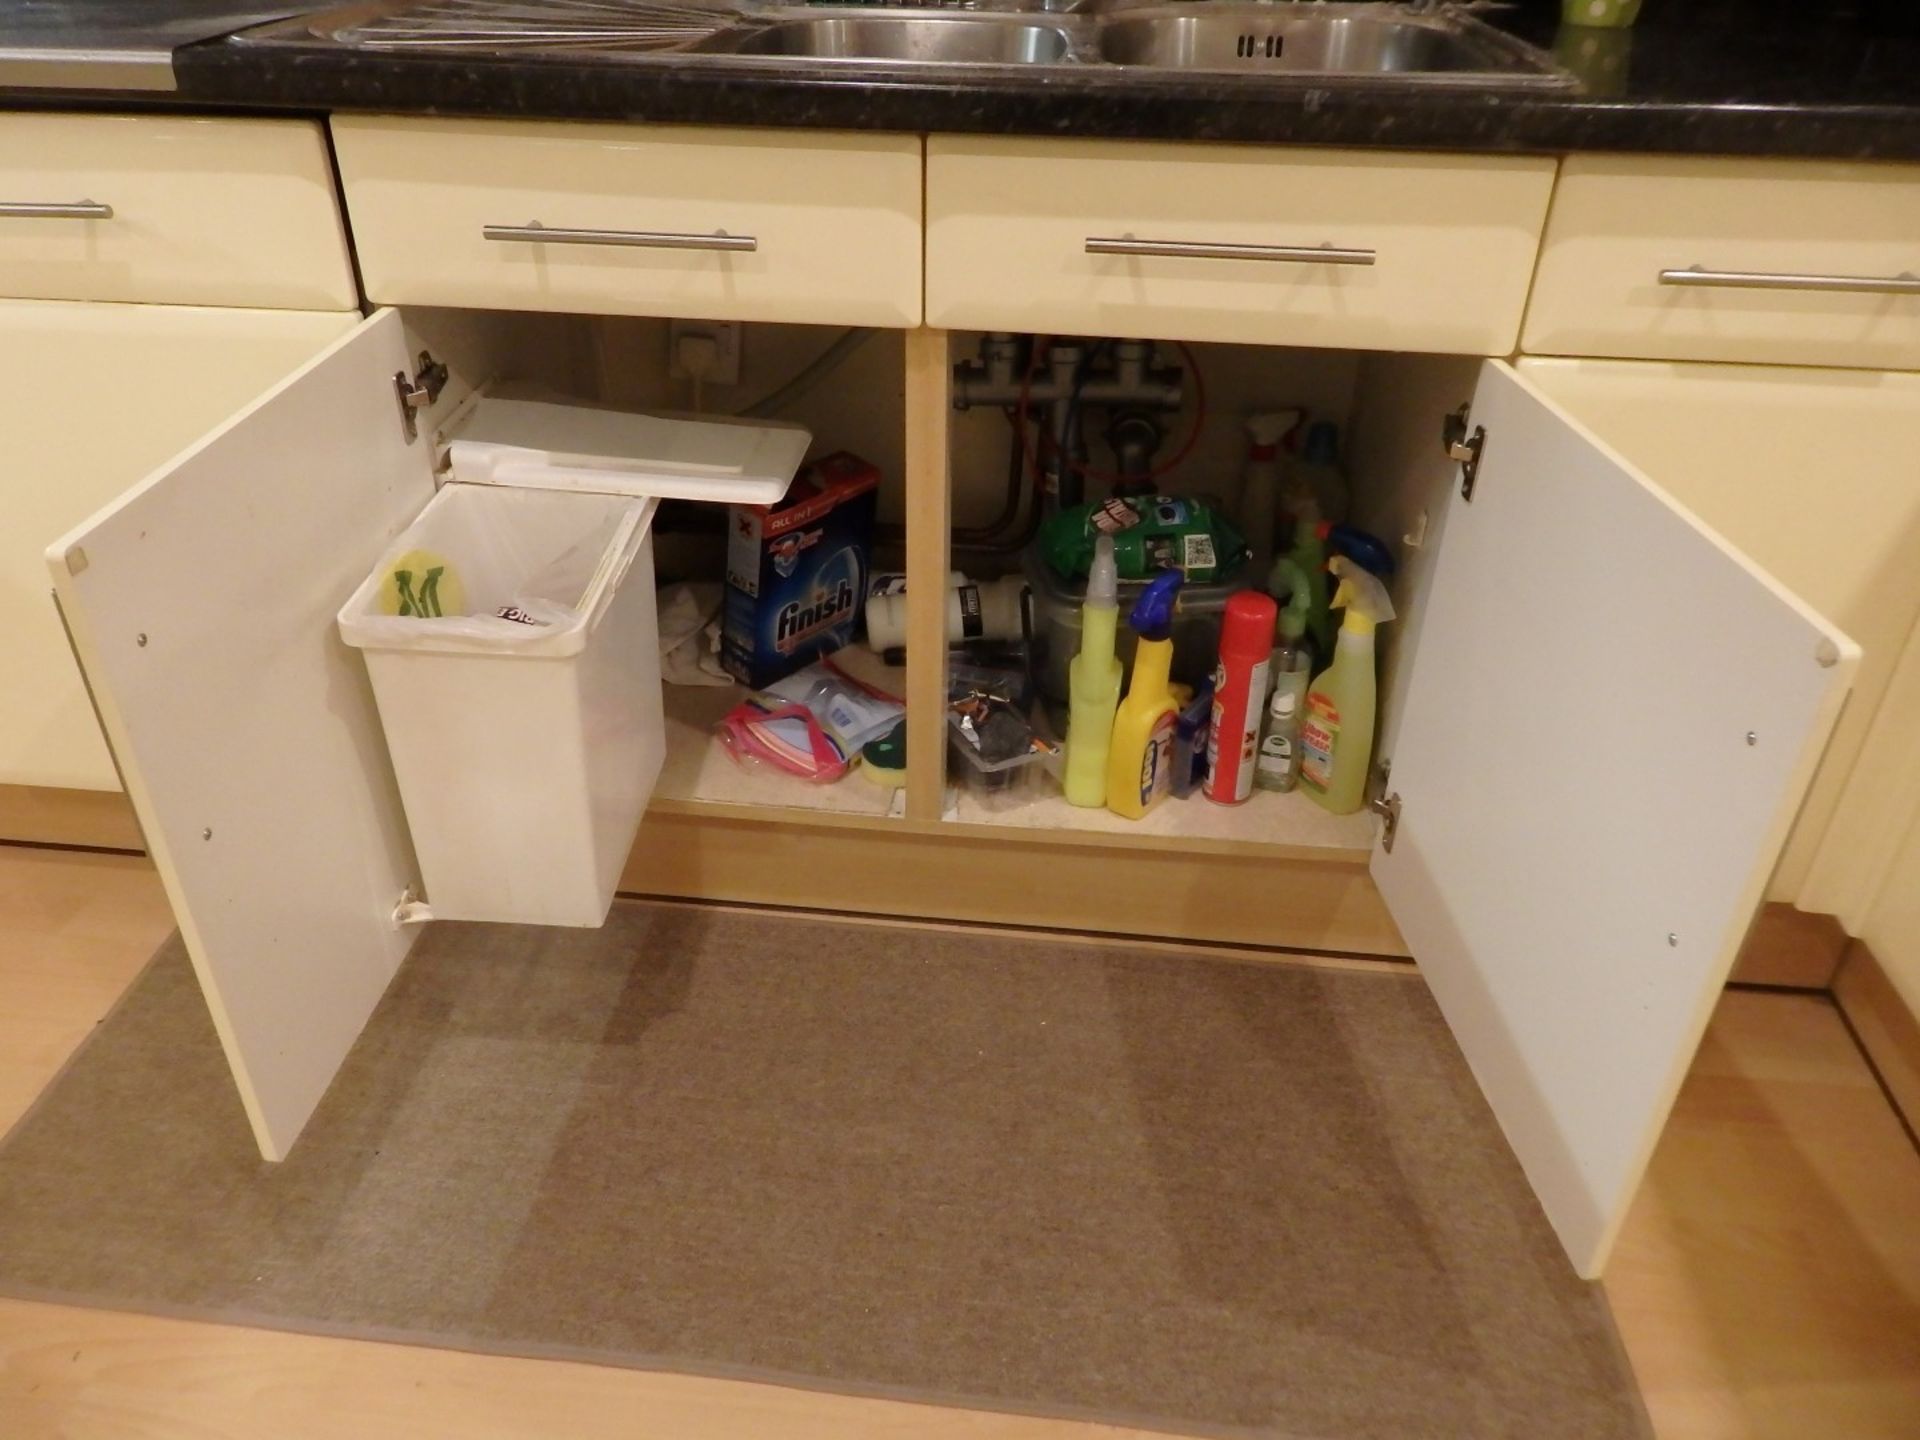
xmin=720 ymin=451 xmax=879 ymax=689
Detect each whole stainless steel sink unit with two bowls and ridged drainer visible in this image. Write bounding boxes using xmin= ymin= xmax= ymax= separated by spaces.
xmin=242 ymin=0 xmax=1572 ymax=88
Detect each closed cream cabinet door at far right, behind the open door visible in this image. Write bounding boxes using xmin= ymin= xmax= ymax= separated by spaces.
xmin=1517 ymin=359 xmax=1920 ymax=916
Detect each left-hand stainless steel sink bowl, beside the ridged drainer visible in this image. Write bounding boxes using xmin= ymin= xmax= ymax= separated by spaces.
xmin=693 ymin=12 xmax=1073 ymax=65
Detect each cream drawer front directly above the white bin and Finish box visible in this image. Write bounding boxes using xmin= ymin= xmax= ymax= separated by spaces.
xmin=334 ymin=117 xmax=920 ymax=326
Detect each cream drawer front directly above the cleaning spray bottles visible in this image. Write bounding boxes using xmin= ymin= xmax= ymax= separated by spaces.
xmin=927 ymin=136 xmax=1553 ymax=355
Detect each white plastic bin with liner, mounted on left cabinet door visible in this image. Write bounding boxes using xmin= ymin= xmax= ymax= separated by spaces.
xmin=340 ymin=484 xmax=666 ymax=925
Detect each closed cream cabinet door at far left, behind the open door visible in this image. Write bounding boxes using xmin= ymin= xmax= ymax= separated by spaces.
xmin=0 ymin=300 xmax=359 ymax=802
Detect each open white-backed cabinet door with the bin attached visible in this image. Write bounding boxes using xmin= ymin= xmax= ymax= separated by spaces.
xmin=48 ymin=311 xmax=434 ymax=1160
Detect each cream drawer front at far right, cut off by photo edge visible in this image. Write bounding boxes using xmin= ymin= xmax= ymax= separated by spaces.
xmin=1523 ymin=156 xmax=1920 ymax=369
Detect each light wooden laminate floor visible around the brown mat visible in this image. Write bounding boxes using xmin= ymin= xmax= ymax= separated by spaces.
xmin=0 ymin=847 xmax=1920 ymax=1440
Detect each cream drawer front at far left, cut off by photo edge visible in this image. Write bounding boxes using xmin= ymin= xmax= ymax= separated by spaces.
xmin=0 ymin=115 xmax=357 ymax=311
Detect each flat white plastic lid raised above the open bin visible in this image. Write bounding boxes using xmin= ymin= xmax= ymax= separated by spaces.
xmin=447 ymin=396 xmax=812 ymax=505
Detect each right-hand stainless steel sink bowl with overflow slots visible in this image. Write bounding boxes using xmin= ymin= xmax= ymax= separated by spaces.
xmin=1098 ymin=0 xmax=1536 ymax=79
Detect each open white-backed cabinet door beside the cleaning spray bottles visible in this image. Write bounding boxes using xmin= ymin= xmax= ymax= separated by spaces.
xmin=1373 ymin=361 xmax=1859 ymax=1277
